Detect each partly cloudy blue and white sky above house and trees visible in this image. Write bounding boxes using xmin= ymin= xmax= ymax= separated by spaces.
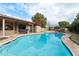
xmin=0 ymin=3 xmax=79 ymax=26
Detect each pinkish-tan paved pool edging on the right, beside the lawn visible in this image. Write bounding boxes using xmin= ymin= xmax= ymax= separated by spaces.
xmin=62 ymin=34 xmax=79 ymax=56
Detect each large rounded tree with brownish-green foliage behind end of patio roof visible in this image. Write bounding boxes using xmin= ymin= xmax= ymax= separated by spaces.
xmin=32 ymin=13 xmax=47 ymax=28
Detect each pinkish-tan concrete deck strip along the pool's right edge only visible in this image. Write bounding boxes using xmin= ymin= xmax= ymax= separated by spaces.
xmin=62 ymin=36 xmax=79 ymax=56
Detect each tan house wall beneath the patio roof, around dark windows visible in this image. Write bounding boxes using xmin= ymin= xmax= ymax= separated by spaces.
xmin=0 ymin=21 xmax=34 ymax=36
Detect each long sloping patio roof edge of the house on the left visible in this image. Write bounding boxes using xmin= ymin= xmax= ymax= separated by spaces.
xmin=0 ymin=14 xmax=35 ymax=25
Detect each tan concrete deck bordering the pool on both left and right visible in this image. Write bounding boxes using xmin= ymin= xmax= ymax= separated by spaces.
xmin=0 ymin=31 xmax=79 ymax=56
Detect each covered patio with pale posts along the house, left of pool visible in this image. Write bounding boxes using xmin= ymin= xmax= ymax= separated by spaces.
xmin=0 ymin=15 xmax=36 ymax=36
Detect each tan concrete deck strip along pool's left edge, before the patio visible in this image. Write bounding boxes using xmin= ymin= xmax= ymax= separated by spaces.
xmin=0 ymin=31 xmax=52 ymax=46
